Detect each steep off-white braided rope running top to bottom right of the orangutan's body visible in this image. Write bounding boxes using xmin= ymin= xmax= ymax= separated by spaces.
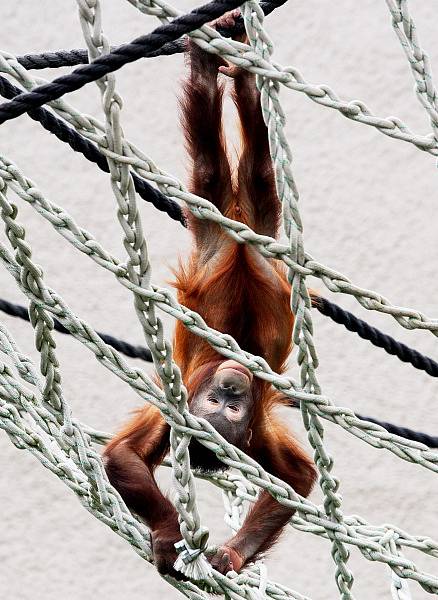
xmin=243 ymin=0 xmax=354 ymax=600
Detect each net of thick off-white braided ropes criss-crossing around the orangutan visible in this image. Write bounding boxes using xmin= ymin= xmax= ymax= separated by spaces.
xmin=0 ymin=0 xmax=438 ymax=600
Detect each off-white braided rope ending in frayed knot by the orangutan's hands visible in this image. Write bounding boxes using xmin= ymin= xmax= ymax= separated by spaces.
xmin=77 ymin=0 xmax=211 ymax=580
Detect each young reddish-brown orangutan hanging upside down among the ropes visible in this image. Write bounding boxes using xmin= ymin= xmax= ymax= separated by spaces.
xmin=105 ymin=12 xmax=315 ymax=576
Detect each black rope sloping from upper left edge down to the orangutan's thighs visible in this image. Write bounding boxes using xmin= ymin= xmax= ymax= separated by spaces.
xmin=0 ymin=75 xmax=187 ymax=227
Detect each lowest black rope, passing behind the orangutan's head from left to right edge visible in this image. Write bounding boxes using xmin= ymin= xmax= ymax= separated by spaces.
xmin=0 ymin=299 xmax=438 ymax=448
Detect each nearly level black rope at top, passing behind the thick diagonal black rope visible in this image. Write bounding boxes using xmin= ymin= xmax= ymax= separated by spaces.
xmin=17 ymin=0 xmax=287 ymax=69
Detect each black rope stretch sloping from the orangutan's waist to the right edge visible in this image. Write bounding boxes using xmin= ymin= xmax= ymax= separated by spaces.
xmin=312 ymin=296 xmax=438 ymax=377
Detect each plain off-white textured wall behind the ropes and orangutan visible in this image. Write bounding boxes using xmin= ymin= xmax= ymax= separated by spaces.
xmin=0 ymin=0 xmax=438 ymax=600
